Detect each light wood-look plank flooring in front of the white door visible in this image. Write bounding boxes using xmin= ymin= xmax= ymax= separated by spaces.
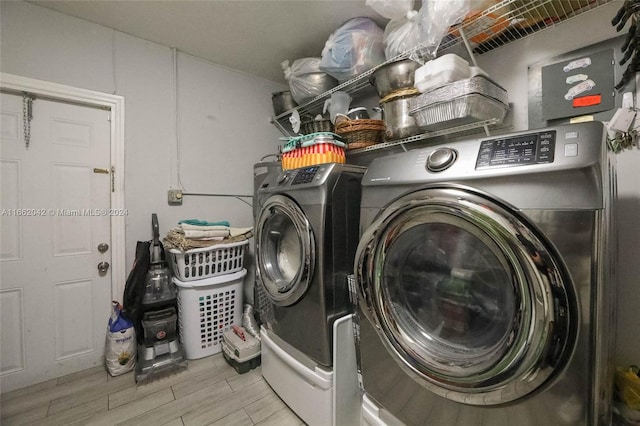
xmin=0 ymin=353 xmax=304 ymax=426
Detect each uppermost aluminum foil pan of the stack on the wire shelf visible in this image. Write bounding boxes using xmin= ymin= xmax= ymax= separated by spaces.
xmin=411 ymin=75 xmax=509 ymax=111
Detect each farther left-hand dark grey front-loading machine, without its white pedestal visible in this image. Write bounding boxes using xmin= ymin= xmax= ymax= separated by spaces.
xmin=255 ymin=163 xmax=365 ymax=367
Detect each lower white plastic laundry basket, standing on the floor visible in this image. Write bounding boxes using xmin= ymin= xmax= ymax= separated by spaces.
xmin=173 ymin=269 xmax=247 ymax=359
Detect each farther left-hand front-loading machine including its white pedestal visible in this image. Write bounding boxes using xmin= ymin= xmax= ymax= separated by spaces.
xmin=255 ymin=163 xmax=365 ymax=425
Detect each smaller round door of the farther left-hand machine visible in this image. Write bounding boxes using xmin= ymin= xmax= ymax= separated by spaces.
xmin=255 ymin=195 xmax=315 ymax=306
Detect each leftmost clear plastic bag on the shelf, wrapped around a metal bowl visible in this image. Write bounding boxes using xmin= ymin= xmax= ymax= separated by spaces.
xmin=281 ymin=58 xmax=338 ymax=105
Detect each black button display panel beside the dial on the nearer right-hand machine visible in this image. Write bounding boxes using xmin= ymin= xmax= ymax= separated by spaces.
xmin=476 ymin=130 xmax=556 ymax=170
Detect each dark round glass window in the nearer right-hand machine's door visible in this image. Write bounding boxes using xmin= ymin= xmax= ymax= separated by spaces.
xmin=382 ymin=215 xmax=518 ymax=374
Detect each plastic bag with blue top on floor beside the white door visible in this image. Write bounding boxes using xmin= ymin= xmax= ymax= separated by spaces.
xmin=104 ymin=301 xmax=137 ymax=376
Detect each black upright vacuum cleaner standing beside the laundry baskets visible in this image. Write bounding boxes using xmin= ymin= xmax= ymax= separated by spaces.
xmin=136 ymin=213 xmax=187 ymax=384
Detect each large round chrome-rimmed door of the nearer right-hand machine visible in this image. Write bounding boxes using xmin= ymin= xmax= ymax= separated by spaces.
xmin=355 ymin=185 xmax=578 ymax=405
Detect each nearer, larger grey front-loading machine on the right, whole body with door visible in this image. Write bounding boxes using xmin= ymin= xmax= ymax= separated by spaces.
xmin=355 ymin=122 xmax=616 ymax=426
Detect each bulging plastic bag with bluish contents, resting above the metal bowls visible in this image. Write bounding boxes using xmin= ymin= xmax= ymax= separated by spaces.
xmin=320 ymin=17 xmax=385 ymax=82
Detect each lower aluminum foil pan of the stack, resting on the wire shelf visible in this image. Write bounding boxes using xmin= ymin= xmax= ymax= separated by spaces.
xmin=410 ymin=94 xmax=509 ymax=131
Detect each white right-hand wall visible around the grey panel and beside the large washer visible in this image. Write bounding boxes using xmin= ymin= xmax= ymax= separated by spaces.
xmin=476 ymin=2 xmax=640 ymax=365
